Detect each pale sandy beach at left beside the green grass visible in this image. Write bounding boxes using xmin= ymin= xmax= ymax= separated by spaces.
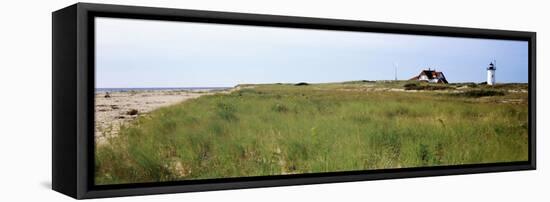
xmin=95 ymin=90 xmax=231 ymax=144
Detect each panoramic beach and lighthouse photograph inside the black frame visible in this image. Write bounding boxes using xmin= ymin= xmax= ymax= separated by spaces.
xmin=94 ymin=17 xmax=529 ymax=185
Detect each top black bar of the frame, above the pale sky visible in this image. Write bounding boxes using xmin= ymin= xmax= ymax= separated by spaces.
xmin=78 ymin=3 xmax=535 ymax=40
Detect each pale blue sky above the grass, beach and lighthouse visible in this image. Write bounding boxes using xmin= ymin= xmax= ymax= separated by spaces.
xmin=95 ymin=18 xmax=528 ymax=88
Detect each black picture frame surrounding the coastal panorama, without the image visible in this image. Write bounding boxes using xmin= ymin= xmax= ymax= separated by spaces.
xmin=52 ymin=3 xmax=536 ymax=199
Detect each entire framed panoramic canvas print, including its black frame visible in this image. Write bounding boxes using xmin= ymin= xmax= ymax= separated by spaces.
xmin=52 ymin=3 xmax=536 ymax=199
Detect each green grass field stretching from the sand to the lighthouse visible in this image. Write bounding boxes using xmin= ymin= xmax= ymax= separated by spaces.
xmin=95 ymin=81 xmax=528 ymax=184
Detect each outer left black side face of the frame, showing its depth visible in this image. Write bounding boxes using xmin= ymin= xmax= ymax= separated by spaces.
xmin=52 ymin=5 xmax=77 ymax=198
